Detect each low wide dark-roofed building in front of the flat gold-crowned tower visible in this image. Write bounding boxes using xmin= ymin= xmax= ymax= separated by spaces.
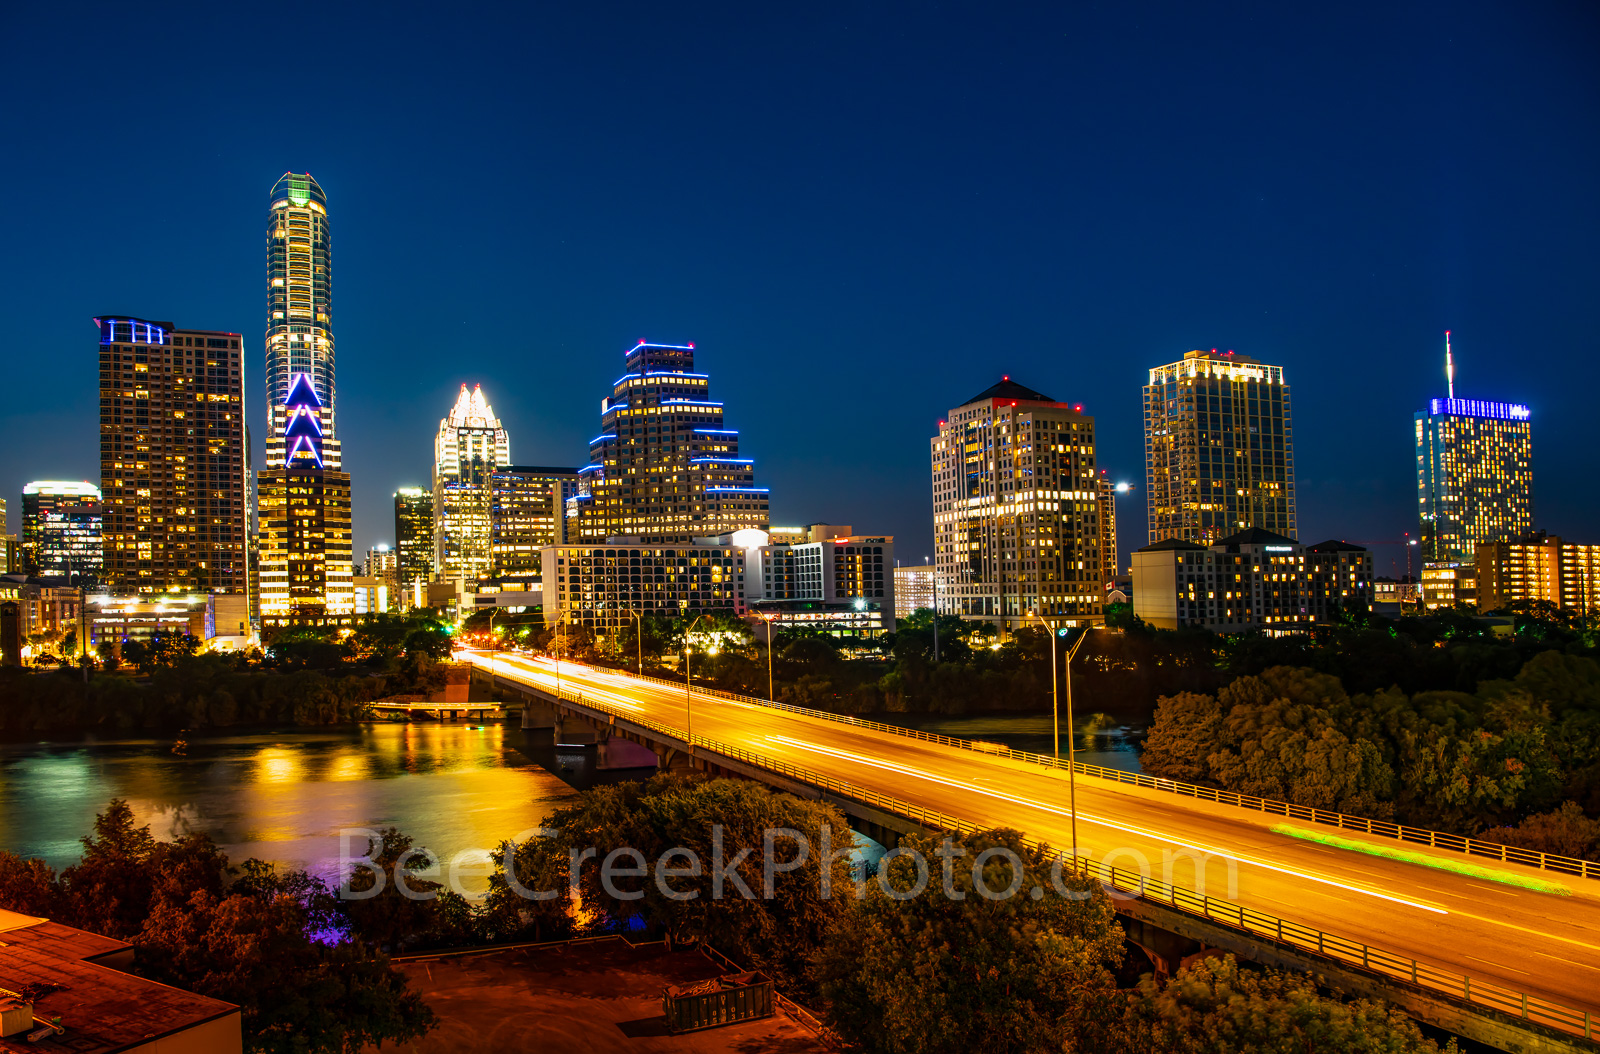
xmin=1133 ymin=528 xmax=1373 ymax=635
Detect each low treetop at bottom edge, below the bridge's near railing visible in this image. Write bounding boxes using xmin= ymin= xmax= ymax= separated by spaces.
xmin=1107 ymin=955 xmax=1456 ymax=1054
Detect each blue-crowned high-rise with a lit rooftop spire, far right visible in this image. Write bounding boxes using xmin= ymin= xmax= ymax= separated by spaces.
xmin=1416 ymin=333 xmax=1533 ymax=563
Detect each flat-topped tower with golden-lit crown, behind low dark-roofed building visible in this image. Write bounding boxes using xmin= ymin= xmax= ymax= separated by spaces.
xmin=1144 ymin=349 xmax=1298 ymax=545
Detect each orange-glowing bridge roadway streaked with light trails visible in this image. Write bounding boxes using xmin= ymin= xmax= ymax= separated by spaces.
xmin=462 ymin=653 xmax=1600 ymax=1014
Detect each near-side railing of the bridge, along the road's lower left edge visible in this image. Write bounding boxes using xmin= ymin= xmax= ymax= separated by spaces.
xmin=521 ymin=681 xmax=1600 ymax=1040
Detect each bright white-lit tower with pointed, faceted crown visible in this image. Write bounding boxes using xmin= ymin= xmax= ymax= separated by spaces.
xmin=434 ymin=384 xmax=510 ymax=579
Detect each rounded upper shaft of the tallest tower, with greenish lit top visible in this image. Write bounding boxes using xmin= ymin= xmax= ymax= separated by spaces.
xmin=267 ymin=173 xmax=341 ymax=472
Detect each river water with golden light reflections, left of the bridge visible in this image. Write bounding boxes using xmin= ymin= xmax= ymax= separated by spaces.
xmin=0 ymin=725 xmax=576 ymax=891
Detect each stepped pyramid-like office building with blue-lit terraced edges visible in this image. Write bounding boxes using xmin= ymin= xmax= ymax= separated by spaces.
xmin=566 ymin=341 xmax=768 ymax=547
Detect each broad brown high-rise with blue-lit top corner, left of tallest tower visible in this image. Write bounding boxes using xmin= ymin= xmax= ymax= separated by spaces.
xmin=94 ymin=315 xmax=250 ymax=595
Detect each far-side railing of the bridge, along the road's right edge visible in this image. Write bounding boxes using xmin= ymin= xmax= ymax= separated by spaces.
xmin=553 ymin=664 xmax=1600 ymax=878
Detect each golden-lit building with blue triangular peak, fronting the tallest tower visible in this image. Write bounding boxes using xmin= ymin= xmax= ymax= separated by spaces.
xmin=258 ymin=374 xmax=355 ymax=629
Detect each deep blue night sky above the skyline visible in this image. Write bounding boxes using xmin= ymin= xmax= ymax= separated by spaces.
xmin=0 ymin=3 xmax=1600 ymax=573
